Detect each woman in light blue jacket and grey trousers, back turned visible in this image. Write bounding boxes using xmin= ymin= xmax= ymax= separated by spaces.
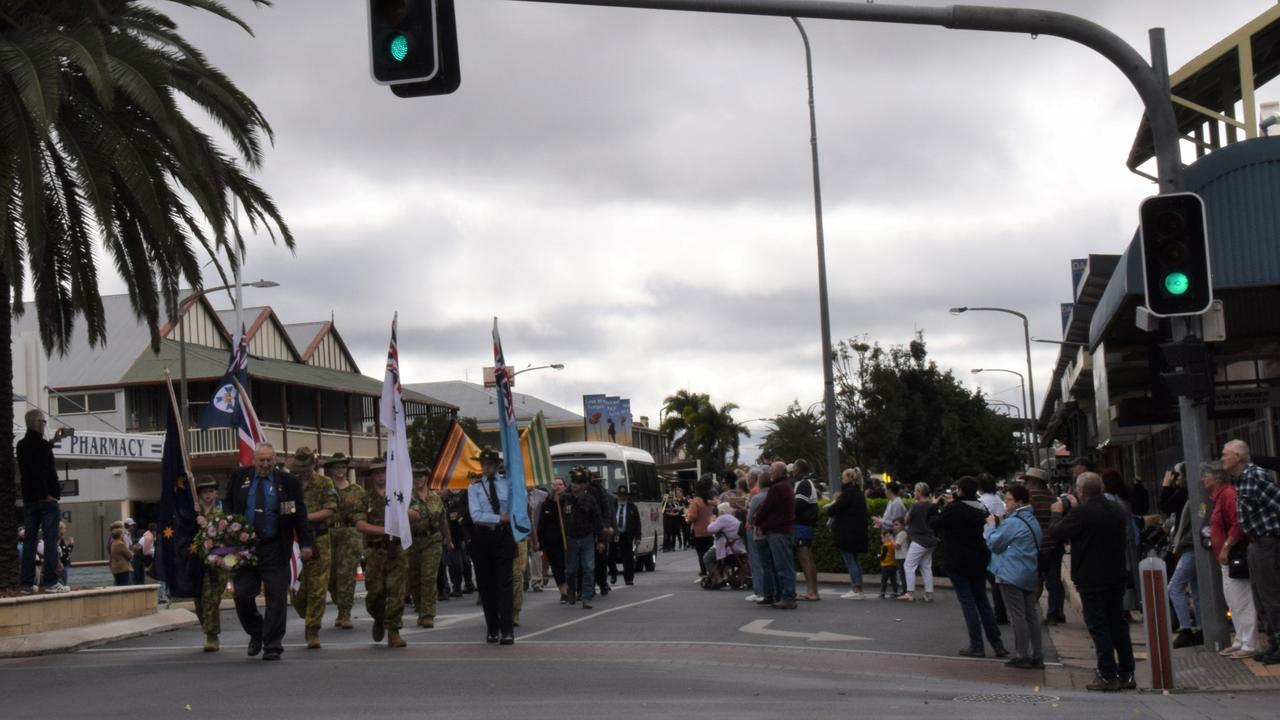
xmin=983 ymin=486 xmax=1044 ymax=670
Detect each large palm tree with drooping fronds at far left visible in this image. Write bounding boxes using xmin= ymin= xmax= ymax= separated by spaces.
xmin=0 ymin=0 xmax=293 ymax=588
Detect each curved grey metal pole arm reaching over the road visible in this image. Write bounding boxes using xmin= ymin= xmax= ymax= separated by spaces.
xmin=506 ymin=0 xmax=1181 ymax=192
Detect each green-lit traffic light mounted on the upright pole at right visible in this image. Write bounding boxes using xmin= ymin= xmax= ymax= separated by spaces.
xmin=1138 ymin=192 xmax=1213 ymax=318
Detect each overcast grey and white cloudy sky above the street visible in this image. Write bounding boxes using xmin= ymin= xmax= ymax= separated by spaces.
xmin=94 ymin=0 xmax=1280 ymax=453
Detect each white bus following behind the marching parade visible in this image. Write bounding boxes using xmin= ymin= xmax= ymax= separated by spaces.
xmin=550 ymin=442 xmax=662 ymax=573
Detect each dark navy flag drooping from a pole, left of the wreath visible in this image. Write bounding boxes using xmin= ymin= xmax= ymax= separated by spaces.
xmin=155 ymin=413 xmax=205 ymax=597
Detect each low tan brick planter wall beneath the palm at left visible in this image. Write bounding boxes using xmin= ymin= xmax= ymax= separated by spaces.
xmin=0 ymin=584 xmax=157 ymax=637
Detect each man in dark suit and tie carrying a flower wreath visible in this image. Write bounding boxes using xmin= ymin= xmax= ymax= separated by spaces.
xmin=225 ymin=442 xmax=315 ymax=660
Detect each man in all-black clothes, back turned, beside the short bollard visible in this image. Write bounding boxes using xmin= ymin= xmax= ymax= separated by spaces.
xmin=1048 ymin=473 xmax=1137 ymax=692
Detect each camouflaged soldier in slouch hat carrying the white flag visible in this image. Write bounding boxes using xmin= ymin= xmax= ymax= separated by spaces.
xmin=356 ymin=461 xmax=408 ymax=647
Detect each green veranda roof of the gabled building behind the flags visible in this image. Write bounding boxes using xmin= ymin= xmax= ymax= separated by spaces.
xmin=120 ymin=340 xmax=457 ymax=410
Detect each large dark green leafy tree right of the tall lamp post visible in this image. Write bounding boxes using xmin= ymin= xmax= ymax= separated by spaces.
xmin=836 ymin=332 xmax=1021 ymax=487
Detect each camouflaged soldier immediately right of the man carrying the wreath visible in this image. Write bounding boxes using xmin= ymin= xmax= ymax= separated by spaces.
xmin=289 ymin=447 xmax=338 ymax=650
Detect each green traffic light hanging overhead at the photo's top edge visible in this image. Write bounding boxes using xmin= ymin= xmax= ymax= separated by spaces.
xmin=369 ymin=0 xmax=460 ymax=96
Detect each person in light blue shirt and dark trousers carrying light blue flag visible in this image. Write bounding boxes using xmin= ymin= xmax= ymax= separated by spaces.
xmin=467 ymin=450 xmax=516 ymax=644
